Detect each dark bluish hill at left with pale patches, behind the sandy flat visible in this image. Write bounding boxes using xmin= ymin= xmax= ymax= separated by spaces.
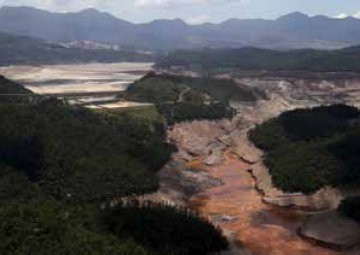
xmin=0 ymin=33 xmax=154 ymax=65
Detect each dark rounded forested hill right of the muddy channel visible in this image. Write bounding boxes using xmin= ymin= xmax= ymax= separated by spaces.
xmin=249 ymin=105 xmax=360 ymax=193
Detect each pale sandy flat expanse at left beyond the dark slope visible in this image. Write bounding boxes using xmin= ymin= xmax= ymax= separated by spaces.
xmin=0 ymin=62 xmax=153 ymax=94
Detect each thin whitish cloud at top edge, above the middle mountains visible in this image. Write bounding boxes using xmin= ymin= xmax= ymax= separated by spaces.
xmin=134 ymin=0 xmax=242 ymax=9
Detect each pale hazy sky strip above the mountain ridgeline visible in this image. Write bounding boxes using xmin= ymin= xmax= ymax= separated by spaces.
xmin=0 ymin=0 xmax=360 ymax=23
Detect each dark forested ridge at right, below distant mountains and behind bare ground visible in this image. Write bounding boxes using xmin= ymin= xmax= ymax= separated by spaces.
xmin=156 ymin=47 xmax=360 ymax=72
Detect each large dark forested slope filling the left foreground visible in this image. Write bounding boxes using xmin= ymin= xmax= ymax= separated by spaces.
xmin=0 ymin=77 xmax=227 ymax=255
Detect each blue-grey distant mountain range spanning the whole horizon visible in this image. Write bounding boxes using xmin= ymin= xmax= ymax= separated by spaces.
xmin=0 ymin=7 xmax=360 ymax=50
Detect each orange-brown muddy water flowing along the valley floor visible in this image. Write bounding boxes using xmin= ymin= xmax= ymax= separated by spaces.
xmin=190 ymin=158 xmax=339 ymax=255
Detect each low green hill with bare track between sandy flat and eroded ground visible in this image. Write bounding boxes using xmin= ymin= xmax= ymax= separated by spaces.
xmin=125 ymin=73 xmax=261 ymax=124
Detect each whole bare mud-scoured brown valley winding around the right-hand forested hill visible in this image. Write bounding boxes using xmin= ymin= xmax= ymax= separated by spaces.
xmin=141 ymin=68 xmax=360 ymax=255
